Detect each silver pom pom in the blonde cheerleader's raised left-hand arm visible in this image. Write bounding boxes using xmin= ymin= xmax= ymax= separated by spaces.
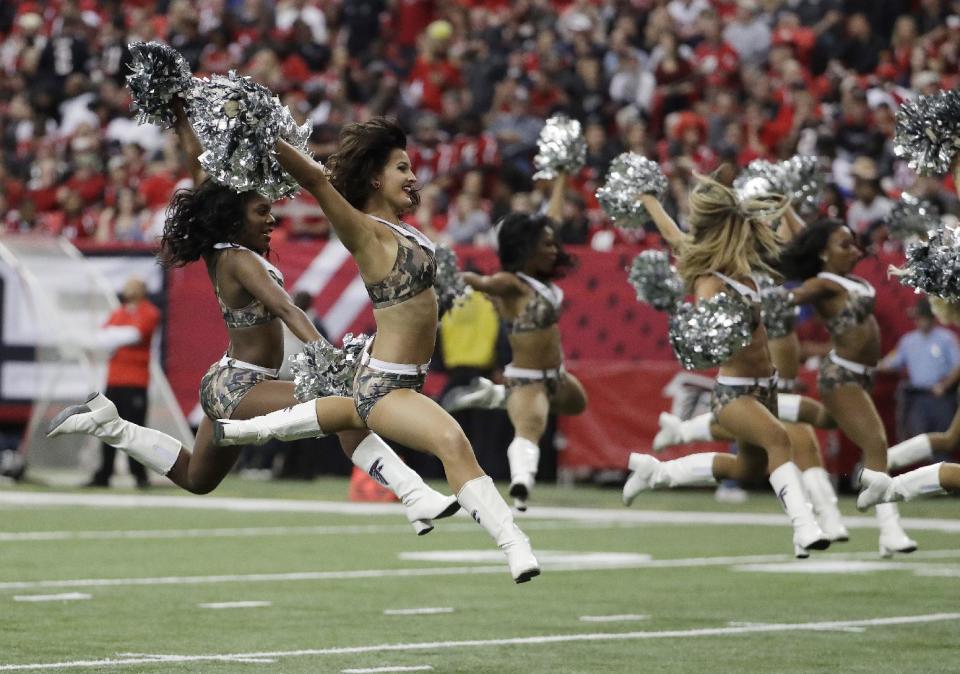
xmin=597 ymin=152 xmax=667 ymax=228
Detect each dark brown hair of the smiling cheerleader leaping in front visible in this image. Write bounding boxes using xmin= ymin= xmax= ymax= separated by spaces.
xmin=327 ymin=117 xmax=420 ymax=210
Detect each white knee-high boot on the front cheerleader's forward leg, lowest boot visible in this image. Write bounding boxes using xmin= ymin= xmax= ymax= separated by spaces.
xmin=457 ymin=475 xmax=540 ymax=583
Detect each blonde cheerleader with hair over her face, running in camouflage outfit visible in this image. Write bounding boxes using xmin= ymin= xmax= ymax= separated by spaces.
xmin=623 ymin=166 xmax=830 ymax=557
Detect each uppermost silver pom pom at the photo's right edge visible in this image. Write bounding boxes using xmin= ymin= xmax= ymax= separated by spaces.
xmin=893 ymin=91 xmax=960 ymax=176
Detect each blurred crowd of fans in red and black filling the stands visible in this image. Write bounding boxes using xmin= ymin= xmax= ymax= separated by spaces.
xmin=0 ymin=0 xmax=960 ymax=247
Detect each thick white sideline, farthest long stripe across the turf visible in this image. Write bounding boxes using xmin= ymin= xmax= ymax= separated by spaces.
xmin=0 ymin=491 xmax=960 ymax=533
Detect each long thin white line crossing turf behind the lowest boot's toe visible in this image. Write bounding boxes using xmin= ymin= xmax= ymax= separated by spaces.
xmin=0 ymin=550 xmax=960 ymax=591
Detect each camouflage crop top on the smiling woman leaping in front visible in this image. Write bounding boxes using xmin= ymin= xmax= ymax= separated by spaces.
xmin=367 ymin=215 xmax=437 ymax=309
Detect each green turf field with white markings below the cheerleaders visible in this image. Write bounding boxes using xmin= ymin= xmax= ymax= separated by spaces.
xmin=0 ymin=479 xmax=960 ymax=673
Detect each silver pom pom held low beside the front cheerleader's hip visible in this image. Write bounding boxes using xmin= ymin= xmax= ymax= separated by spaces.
xmin=288 ymin=332 xmax=368 ymax=402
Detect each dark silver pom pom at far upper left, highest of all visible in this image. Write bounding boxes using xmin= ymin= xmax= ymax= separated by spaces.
xmin=127 ymin=42 xmax=194 ymax=128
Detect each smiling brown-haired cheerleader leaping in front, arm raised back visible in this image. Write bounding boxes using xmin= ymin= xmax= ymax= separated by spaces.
xmin=220 ymin=118 xmax=540 ymax=583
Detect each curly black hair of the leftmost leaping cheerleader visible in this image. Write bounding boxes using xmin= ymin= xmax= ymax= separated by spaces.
xmin=158 ymin=179 xmax=258 ymax=269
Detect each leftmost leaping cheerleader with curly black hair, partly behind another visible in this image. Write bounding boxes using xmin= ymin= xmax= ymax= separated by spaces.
xmin=49 ymin=102 xmax=457 ymax=534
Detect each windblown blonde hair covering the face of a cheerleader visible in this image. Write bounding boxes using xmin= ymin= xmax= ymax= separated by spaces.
xmin=677 ymin=175 xmax=789 ymax=288
